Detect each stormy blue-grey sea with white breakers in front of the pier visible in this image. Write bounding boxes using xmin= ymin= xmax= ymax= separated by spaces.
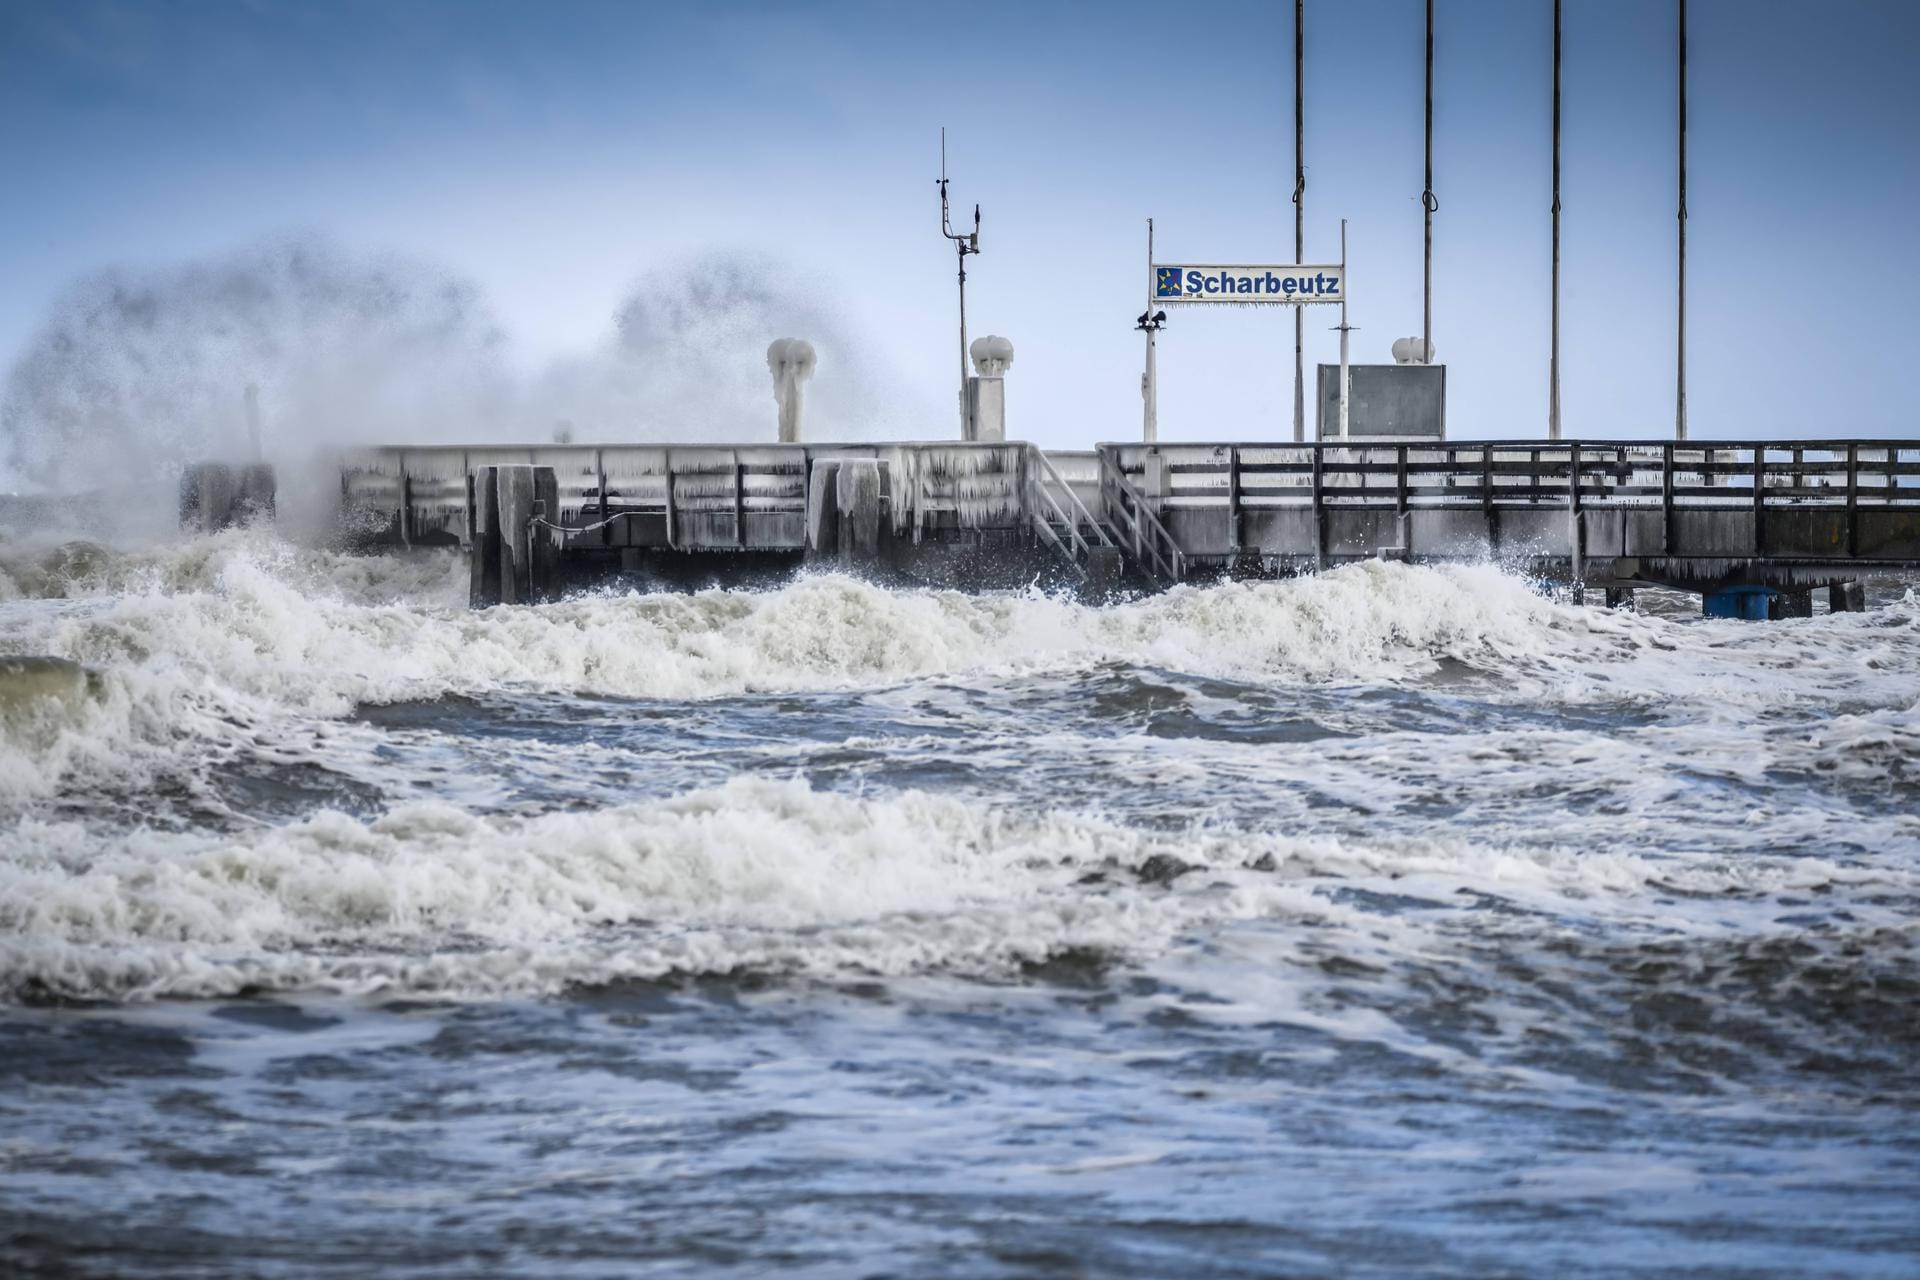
xmin=0 ymin=532 xmax=1920 ymax=1278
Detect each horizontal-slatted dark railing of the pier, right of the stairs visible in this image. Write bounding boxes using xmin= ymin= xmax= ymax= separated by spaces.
xmin=1100 ymin=439 xmax=1920 ymax=581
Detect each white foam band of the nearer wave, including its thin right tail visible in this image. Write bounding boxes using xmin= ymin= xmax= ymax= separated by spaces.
xmin=0 ymin=767 xmax=1920 ymax=998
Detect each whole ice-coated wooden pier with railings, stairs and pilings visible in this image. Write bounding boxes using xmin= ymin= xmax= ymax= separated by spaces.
xmin=326 ymin=439 xmax=1920 ymax=618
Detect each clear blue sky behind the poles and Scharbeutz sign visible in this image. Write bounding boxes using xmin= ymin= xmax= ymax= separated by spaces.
xmin=0 ymin=0 xmax=1920 ymax=445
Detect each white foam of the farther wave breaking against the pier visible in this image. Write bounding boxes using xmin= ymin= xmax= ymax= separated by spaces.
xmin=0 ymin=532 xmax=1920 ymax=800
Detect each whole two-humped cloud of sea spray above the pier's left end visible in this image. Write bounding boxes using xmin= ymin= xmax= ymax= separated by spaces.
xmin=0 ymin=234 xmax=924 ymax=521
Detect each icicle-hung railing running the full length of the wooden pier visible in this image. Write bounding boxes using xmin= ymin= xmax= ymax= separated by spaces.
xmin=342 ymin=439 xmax=1920 ymax=581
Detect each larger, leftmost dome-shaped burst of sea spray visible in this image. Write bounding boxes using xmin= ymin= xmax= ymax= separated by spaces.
xmin=0 ymin=236 xmax=513 ymax=506
